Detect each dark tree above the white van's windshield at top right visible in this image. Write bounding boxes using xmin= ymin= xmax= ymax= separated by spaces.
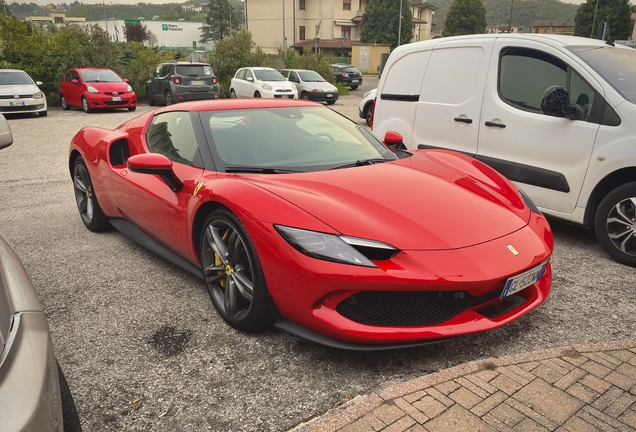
xmin=574 ymin=0 xmax=633 ymax=40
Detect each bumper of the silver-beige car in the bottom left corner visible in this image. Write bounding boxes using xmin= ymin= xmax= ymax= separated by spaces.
xmin=0 ymin=312 xmax=64 ymax=432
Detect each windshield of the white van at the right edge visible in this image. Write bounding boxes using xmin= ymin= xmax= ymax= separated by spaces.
xmin=570 ymin=46 xmax=636 ymax=104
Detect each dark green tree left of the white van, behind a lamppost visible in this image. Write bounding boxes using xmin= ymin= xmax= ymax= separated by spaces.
xmin=360 ymin=0 xmax=413 ymax=48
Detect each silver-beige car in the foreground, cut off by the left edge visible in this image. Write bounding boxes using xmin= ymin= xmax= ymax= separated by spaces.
xmin=0 ymin=114 xmax=82 ymax=432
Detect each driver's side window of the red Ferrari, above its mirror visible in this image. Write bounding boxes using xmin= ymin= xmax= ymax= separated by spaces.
xmin=146 ymin=111 xmax=199 ymax=165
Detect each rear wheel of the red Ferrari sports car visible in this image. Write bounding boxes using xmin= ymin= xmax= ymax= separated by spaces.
xmin=73 ymin=156 xmax=110 ymax=232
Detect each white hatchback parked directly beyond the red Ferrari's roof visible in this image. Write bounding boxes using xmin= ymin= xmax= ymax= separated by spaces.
xmin=230 ymin=67 xmax=298 ymax=99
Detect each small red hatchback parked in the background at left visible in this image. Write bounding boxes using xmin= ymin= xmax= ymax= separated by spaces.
xmin=60 ymin=68 xmax=137 ymax=113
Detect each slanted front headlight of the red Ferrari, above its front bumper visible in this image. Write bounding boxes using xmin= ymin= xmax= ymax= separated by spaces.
xmin=274 ymin=225 xmax=399 ymax=267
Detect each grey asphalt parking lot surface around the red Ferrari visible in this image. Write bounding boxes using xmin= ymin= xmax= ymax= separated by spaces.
xmin=0 ymin=89 xmax=636 ymax=432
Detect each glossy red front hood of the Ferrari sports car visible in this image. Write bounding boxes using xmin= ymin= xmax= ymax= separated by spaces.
xmin=250 ymin=155 xmax=530 ymax=250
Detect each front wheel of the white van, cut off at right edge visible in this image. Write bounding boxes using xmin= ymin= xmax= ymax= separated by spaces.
xmin=594 ymin=182 xmax=636 ymax=267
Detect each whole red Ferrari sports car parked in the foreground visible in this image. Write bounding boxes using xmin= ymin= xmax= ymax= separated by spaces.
xmin=69 ymin=99 xmax=553 ymax=349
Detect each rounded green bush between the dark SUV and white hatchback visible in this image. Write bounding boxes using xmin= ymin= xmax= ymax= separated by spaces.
xmin=208 ymin=30 xmax=267 ymax=96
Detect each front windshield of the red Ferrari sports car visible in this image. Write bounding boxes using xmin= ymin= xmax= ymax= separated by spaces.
xmin=201 ymin=106 xmax=398 ymax=173
